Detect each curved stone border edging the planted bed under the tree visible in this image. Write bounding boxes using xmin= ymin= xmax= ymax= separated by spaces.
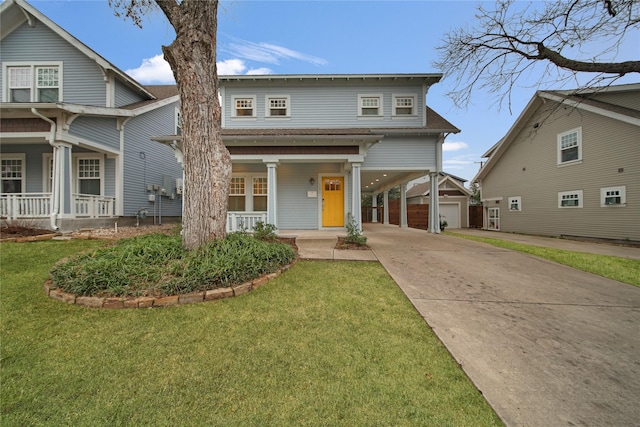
xmin=43 ymin=260 xmax=295 ymax=308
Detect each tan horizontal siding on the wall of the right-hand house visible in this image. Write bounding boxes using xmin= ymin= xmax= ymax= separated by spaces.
xmin=482 ymin=100 xmax=640 ymax=241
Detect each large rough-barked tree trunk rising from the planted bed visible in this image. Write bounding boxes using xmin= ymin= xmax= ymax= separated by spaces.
xmin=157 ymin=0 xmax=231 ymax=249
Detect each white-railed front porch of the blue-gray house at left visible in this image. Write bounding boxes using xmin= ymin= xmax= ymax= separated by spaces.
xmin=0 ymin=109 xmax=122 ymax=230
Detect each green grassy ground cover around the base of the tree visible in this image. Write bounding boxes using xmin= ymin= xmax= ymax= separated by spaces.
xmin=51 ymin=233 xmax=295 ymax=296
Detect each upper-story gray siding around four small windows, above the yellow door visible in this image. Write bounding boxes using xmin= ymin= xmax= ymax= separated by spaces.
xmin=222 ymin=82 xmax=425 ymax=129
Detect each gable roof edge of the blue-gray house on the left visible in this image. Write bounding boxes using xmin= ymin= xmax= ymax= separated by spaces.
xmin=0 ymin=0 xmax=155 ymax=99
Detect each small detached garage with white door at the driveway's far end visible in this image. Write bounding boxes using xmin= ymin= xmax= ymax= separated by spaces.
xmin=407 ymin=172 xmax=471 ymax=228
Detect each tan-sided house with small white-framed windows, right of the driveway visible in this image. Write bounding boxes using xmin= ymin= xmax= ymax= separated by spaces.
xmin=473 ymin=83 xmax=640 ymax=242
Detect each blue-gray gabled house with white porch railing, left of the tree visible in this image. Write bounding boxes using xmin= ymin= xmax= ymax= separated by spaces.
xmin=0 ymin=0 xmax=182 ymax=231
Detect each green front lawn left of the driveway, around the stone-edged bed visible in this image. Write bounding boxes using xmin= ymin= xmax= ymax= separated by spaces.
xmin=0 ymin=240 xmax=501 ymax=426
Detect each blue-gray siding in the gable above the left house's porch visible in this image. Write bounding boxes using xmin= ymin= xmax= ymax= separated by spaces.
xmin=2 ymin=21 xmax=106 ymax=107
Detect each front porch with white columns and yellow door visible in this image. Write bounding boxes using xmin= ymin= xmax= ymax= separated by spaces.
xmin=152 ymin=129 xmax=439 ymax=232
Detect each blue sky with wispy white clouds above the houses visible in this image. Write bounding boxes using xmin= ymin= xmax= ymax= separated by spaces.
xmin=30 ymin=0 xmax=640 ymax=184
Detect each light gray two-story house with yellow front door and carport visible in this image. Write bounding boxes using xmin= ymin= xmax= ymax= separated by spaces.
xmin=154 ymin=74 xmax=459 ymax=233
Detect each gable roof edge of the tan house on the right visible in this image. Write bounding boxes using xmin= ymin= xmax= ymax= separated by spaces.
xmin=471 ymin=83 xmax=640 ymax=182
